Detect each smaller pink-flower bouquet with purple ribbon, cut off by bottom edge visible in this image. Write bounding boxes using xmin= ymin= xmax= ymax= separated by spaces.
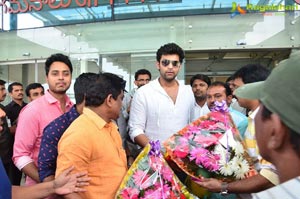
xmin=116 ymin=141 xmax=196 ymax=199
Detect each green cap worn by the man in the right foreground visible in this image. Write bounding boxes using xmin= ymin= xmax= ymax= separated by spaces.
xmin=234 ymin=51 xmax=300 ymax=133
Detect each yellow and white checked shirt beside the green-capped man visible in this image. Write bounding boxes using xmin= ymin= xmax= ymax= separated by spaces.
xmin=244 ymin=107 xmax=279 ymax=185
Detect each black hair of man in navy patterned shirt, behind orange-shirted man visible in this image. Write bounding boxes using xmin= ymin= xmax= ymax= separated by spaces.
xmin=74 ymin=73 xmax=98 ymax=104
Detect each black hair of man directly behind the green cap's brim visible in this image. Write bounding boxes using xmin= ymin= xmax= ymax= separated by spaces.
xmin=232 ymin=64 xmax=271 ymax=84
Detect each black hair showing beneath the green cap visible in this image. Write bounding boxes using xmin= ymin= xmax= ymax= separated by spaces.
xmin=261 ymin=104 xmax=300 ymax=158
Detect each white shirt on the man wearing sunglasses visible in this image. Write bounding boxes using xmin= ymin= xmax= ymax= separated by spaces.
xmin=129 ymin=79 xmax=195 ymax=143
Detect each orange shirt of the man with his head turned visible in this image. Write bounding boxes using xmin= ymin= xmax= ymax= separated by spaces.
xmin=56 ymin=108 xmax=127 ymax=199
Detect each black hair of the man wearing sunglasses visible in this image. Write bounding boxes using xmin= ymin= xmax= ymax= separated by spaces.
xmin=156 ymin=43 xmax=184 ymax=63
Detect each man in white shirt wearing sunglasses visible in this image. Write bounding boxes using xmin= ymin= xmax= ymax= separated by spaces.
xmin=129 ymin=43 xmax=195 ymax=147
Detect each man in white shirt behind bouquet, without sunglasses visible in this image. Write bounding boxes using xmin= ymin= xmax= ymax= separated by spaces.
xmin=190 ymin=74 xmax=211 ymax=122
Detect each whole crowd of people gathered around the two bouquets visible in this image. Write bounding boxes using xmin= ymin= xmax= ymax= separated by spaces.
xmin=0 ymin=43 xmax=300 ymax=199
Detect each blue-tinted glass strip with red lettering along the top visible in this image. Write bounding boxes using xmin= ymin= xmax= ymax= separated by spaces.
xmin=0 ymin=0 xmax=300 ymax=30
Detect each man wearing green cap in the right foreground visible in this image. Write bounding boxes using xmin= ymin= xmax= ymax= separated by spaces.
xmin=236 ymin=51 xmax=300 ymax=199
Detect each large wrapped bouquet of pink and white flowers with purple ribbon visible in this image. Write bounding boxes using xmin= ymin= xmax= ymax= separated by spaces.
xmin=164 ymin=101 xmax=255 ymax=181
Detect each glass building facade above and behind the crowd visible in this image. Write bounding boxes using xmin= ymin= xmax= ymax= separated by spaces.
xmin=0 ymin=0 xmax=300 ymax=102
